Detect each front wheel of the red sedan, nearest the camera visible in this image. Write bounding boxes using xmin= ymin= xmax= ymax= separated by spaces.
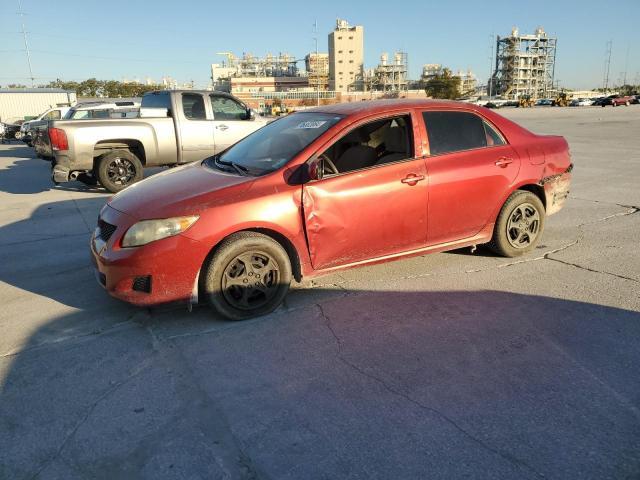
xmin=201 ymin=232 xmax=292 ymax=320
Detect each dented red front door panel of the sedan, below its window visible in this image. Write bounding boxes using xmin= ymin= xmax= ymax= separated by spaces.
xmin=303 ymin=158 xmax=428 ymax=269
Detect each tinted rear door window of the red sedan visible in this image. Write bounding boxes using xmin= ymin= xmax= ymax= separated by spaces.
xmin=422 ymin=112 xmax=487 ymax=155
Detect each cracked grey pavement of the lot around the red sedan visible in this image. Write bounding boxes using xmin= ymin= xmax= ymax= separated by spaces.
xmin=0 ymin=105 xmax=640 ymax=480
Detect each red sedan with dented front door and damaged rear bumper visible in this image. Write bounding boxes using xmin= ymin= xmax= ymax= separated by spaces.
xmin=91 ymin=100 xmax=572 ymax=319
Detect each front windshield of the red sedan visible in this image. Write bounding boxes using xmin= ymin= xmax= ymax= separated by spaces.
xmin=212 ymin=112 xmax=342 ymax=175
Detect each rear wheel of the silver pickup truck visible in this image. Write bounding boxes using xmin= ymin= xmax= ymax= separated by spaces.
xmin=93 ymin=150 xmax=143 ymax=193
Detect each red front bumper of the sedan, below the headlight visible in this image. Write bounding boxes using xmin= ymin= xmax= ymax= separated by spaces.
xmin=91 ymin=206 xmax=209 ymax=306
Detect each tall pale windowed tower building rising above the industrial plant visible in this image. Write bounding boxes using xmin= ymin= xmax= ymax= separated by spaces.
xmin=329 ymin=19 xmax=364 ymax=92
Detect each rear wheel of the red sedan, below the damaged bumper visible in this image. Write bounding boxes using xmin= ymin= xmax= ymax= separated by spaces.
xmin=489 ymin=190 xmax=545 ymax=258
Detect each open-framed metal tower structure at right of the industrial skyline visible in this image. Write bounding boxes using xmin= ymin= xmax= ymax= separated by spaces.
xmin=491 ymin=27 xmax=557 ymax=99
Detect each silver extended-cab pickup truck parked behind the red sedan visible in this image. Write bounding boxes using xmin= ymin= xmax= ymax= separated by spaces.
xmin=48 ymin=90 xmax=267 ymax=192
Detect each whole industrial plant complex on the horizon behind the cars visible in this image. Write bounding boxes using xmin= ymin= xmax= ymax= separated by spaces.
xmin=204 ymin=19 xmax=558 ymax=107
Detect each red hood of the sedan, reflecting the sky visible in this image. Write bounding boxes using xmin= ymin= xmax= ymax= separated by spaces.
xmin=108 ymin=162 xmax=256 ymax=220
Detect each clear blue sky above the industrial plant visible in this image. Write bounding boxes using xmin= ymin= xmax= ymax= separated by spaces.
xmin=0 ymin=0 xmax=640 ymax=89
